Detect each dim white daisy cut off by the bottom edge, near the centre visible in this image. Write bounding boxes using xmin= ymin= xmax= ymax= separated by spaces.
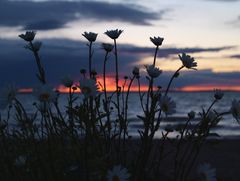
xmin=107 ymin=165 xmax=130 ymax=181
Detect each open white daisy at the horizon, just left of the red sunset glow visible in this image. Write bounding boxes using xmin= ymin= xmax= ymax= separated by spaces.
xmin=79 ymin=79 xmax=98 ymax=97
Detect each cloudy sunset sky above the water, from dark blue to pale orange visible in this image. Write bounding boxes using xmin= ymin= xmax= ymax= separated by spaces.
xmin=0 ymin=0 xmax=240 ymax=91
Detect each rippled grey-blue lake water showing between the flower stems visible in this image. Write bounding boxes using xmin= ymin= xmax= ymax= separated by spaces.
xmin=1 ymin=92 xmax=240 ymax=138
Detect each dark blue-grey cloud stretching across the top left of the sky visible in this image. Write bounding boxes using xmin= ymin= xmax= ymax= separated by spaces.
xmin=0 ymin=0 xmax=161 ymax=30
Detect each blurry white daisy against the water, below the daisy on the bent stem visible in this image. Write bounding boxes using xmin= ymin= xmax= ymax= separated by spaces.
xmin=159 ymin=96 xmax=176 ymax=114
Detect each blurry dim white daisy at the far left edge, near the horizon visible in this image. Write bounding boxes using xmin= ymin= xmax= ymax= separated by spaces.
xmin=0 ymin=85 xmax=17 ymax=109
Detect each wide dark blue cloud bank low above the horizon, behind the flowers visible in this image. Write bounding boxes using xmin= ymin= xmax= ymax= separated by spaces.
xmin=0 ymin=37 xmax=236 ymax=87
